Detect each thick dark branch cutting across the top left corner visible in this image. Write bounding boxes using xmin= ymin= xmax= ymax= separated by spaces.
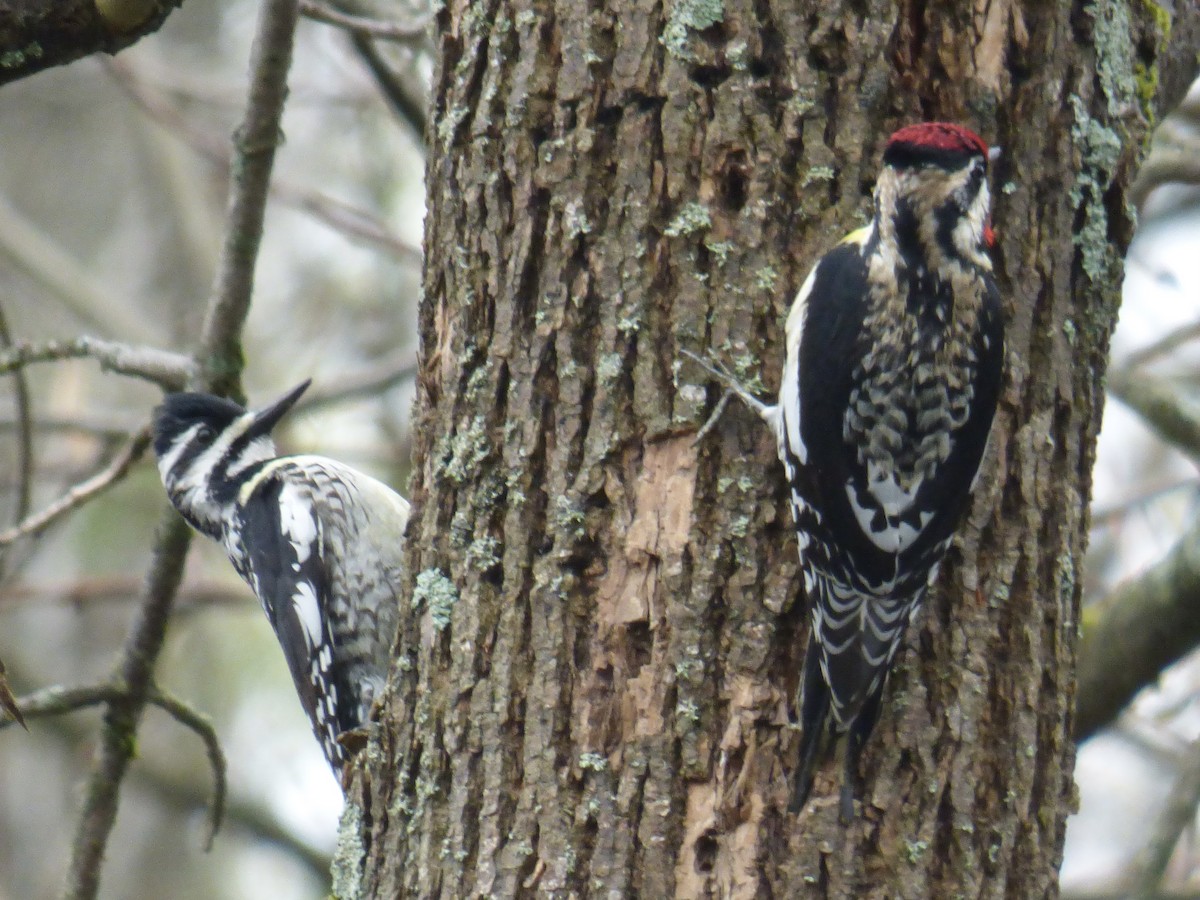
xmin=0 ymin=0 xmax=182 ymax=84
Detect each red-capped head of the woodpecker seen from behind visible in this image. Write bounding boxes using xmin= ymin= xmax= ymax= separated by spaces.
xmin=876 ymin=122 xmax=998 ymax=262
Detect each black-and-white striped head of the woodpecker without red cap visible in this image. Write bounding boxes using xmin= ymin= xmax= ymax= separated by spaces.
xmin=154 ymin=380 xmax=310 ymax=538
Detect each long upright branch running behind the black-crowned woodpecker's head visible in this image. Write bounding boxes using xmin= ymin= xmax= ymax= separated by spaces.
xmin=64 ymin=0 xmax=299 ymax=900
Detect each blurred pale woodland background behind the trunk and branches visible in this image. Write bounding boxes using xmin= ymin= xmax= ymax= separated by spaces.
xmin=0 ymin=2 xmax=1200 ymax=900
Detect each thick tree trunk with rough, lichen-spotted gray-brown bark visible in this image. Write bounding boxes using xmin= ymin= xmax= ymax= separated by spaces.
xmin=335 ymin=0 xmax=1196 ymax=900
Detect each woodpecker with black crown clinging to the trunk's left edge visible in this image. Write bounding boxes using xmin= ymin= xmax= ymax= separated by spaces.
xmin=154 ymin=382 xmax=408 ymax=773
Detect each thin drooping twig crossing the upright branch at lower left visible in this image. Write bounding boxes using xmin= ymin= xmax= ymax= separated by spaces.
xmin=0 ymin=684 xmax=227 ymax=851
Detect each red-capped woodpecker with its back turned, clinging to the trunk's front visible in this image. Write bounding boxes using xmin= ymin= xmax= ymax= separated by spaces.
xmin=686 ymin=122 xmax=1004 ymax=820
